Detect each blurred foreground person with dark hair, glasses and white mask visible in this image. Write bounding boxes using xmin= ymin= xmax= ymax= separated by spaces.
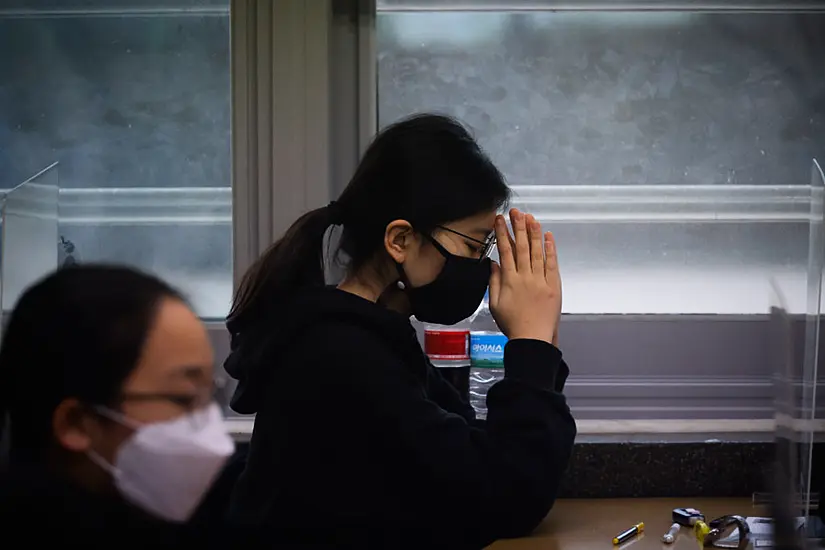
xmin=0 ymin=265 xmax=234 ymax=543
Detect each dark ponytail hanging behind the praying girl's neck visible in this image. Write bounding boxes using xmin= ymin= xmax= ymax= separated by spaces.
xmin=226 ymin=203 xmax=337 ymax=336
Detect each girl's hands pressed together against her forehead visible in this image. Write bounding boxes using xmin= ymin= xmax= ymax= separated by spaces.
xmin=490 ymin=209 xmax=561 ymax=343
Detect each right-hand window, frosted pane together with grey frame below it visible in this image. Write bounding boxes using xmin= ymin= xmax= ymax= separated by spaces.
xmin=374 ymin=0 xmax=825 ymax=422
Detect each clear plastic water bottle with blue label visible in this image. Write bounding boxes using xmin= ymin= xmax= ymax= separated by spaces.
xmin=469 ymin=291 xmax=507 ymax=419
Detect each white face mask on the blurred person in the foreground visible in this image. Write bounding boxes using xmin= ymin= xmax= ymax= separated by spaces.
xmin=88 ymin=403 xmax=235 ymax=522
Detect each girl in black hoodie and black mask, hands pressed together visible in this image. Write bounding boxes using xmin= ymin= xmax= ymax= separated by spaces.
xmin=226 ymin=114 xmax=576 ymax=547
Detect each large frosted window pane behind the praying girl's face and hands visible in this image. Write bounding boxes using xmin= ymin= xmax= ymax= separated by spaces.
xmin=377 ymin=9 xmax=825 ymax=313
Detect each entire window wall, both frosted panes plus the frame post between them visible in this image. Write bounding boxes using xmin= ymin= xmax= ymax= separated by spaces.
xmin=0 ymin=0 xmax=825 ymax=424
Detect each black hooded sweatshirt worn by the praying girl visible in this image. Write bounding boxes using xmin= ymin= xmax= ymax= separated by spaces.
xmin=226 ymin=288 xmax=576 ymax=548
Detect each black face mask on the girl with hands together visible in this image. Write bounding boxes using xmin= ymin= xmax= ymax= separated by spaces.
xmin=398 ymin=238 xmax=492 ymax=325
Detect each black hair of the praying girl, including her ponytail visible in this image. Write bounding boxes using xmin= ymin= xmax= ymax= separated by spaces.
xmin=227 ymin=114 xmax=510 ymax=335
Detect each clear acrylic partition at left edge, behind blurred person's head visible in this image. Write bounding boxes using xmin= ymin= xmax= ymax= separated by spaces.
xmin=0 ymin=163 xmax=59 ymax=316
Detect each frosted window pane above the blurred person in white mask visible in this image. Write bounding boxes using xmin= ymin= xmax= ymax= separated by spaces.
xmin=0 ymin=0 xmax=232 ymax=317
